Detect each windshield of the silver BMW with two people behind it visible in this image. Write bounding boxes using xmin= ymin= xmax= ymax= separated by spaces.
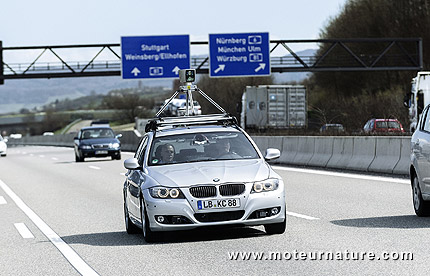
xmin=149 ymin=132 xmax=258 ymax=166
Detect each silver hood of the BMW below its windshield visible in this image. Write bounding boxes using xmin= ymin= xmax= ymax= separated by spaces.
xmin=148 ymin=159 xmax=270 ymax=187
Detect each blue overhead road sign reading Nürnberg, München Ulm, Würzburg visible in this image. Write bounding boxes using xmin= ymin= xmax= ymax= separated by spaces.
xmin=209 ymin=33 xmax=270 ymax=77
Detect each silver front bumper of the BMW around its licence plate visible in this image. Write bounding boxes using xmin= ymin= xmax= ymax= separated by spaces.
xmin=143 ymin=184 xmax=286 ymax=231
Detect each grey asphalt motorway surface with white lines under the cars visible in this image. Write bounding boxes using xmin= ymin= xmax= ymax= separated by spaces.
xmin=0 ymin=147 xmax=430 ymax=275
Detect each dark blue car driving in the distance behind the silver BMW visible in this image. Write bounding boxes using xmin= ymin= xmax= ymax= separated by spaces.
xmin=74 ymin=126 xmax=122 ymax=162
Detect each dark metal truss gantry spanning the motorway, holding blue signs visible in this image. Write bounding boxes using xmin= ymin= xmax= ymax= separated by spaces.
xmin=0 ymin=38 xmax=423 ymax=84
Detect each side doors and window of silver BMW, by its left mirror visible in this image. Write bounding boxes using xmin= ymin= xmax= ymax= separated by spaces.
xmin=127 ymin=136 xmax=148 ymax=219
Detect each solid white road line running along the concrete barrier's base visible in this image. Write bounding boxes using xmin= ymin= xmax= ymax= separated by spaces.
xmin=273 ymin=166 xmax=411 ymax=184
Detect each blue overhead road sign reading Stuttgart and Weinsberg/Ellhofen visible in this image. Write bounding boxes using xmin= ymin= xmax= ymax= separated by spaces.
xmin=121 ymin=35 xmax=190 ymax=79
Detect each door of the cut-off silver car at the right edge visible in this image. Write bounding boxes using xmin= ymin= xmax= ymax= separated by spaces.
xmin=415 ymin=107 xmax=430 ymax=194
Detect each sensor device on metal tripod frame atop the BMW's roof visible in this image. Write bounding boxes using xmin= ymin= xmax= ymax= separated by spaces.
xmin=155 ymin=69 xmax=227 ymax=118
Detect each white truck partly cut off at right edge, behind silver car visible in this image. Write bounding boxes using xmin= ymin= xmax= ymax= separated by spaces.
xmin=404 ymin=72 xmax=430 ymax=133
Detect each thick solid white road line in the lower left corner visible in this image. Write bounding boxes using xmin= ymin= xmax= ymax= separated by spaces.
xmin=0 ymin=180 xmax=98 ymax=275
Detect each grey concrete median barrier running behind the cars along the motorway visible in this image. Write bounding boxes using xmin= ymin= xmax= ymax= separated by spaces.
xmin=8 ymin=131 xmax=410 ymax=175
